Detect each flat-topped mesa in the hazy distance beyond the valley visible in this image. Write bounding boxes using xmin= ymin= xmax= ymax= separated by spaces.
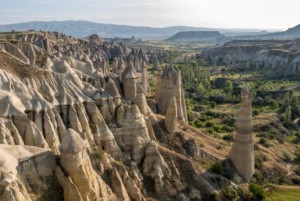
xmin=167 ymin=31 xmax=225 ymax=42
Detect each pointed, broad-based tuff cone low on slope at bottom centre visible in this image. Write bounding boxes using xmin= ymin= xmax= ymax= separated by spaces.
xmin=143 ymin=142 xmax=171 ymax=192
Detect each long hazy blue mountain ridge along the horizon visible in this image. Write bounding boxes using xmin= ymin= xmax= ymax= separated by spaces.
xmin=0 ymin=21 xmax=270 ymax=39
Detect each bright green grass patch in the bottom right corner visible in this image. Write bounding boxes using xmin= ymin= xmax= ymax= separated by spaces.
xmin=266 ymin=186 xmax=300 ymax=201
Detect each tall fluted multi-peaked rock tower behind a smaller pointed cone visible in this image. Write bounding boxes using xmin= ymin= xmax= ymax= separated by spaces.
xmin=155 ymin=64 xmax=187 ymax=121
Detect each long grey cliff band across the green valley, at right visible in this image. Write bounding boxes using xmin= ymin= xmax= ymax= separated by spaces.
xmin=199 ymin=39 xmax=300 ymax=76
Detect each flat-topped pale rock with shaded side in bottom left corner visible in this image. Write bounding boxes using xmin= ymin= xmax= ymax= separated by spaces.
xmin=0 ymin=145 xmax=55 ymax=201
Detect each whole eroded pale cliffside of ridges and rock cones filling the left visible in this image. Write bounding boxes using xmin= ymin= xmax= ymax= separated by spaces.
xmin=0 ymin=32 xmax=253 ymax=201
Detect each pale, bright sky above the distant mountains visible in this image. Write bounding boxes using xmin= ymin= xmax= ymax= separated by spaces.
xmin=0 ymin=0 xmax=300 ymax=30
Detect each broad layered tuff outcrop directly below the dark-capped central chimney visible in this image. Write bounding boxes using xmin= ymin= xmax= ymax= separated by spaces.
xmin=111 ymin=105 xmax=150 ymax=163
